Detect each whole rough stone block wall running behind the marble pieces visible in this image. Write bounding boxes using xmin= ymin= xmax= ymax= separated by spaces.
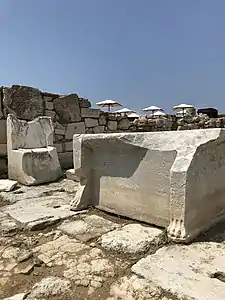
xmin=0 ymin=85 xmax=225 ymax=174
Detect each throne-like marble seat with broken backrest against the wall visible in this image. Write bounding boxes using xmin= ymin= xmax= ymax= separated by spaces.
xmin=7 ymin=114 xmax=61 ymax=185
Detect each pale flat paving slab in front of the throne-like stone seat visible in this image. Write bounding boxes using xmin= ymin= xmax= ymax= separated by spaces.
xmin=1 ymin=179 xmax=83 ymax=230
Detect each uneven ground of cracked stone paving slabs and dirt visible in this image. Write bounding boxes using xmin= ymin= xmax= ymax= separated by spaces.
xmin=0 ymin=179 xmax=225 ymax=300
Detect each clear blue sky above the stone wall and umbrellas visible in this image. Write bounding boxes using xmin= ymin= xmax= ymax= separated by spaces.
xmin=0 ymin=0 xmax=225 ymax=112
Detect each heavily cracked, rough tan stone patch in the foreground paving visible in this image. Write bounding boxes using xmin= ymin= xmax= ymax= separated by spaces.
xmin=34 ymin=235 xmax=126 ymax=289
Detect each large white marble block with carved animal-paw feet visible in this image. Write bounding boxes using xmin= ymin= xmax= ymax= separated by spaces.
xmin=71 ymin=129 xmax=225 ymax=242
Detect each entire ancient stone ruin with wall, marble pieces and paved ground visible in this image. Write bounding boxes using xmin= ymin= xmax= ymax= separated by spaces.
xmin=0 ymin=86 xmax=225 ymax=300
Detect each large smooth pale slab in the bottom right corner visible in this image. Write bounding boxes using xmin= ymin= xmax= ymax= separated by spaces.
xmin=132 ymin=242 xmax=225 ymax=300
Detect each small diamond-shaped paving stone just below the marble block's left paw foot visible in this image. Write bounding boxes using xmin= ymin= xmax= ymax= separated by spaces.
xmin=58 ymin=215 xmax=119 ymax=242
